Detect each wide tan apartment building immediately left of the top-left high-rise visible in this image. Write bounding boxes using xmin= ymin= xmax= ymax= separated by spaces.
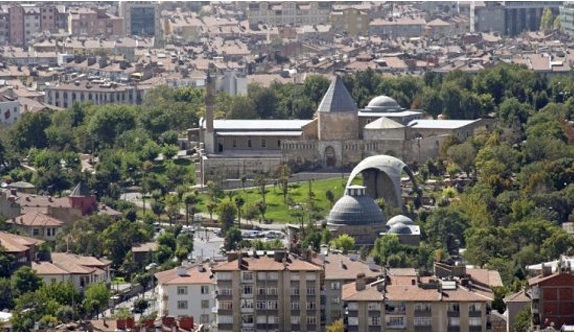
xmin=68 ymin=8 xmax=124 ymax=37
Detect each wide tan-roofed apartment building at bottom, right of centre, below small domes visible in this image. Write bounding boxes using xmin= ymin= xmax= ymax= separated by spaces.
xmin=342 ymin=263 xmax=502 ymax=332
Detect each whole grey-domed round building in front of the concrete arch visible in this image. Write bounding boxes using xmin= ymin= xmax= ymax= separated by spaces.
xmin=327 ymin=185 xmax=386 ymax=245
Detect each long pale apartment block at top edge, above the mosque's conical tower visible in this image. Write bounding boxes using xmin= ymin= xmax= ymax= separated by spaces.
xmin=247 ymin=1 xmax=331 ymax=26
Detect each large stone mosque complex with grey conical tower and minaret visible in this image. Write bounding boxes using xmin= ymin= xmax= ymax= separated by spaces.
xmin=189 ymin=76 xmax=487 ymax=185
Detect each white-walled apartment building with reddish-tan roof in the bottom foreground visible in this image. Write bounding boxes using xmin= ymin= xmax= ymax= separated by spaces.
xmin=155 ymin=259 xmax=215 ymax=331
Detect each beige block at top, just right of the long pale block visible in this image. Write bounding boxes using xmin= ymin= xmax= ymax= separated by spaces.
xmin=331 ymin=3 xmax=371 ymax=37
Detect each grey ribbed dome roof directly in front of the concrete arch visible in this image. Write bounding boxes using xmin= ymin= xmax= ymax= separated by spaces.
xmin=327 ymin=186 xmax=386 ymax=225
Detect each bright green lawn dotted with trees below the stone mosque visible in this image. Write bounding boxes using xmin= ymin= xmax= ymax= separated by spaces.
xmin=198 ymin=177 xmax=362 ymax=223
